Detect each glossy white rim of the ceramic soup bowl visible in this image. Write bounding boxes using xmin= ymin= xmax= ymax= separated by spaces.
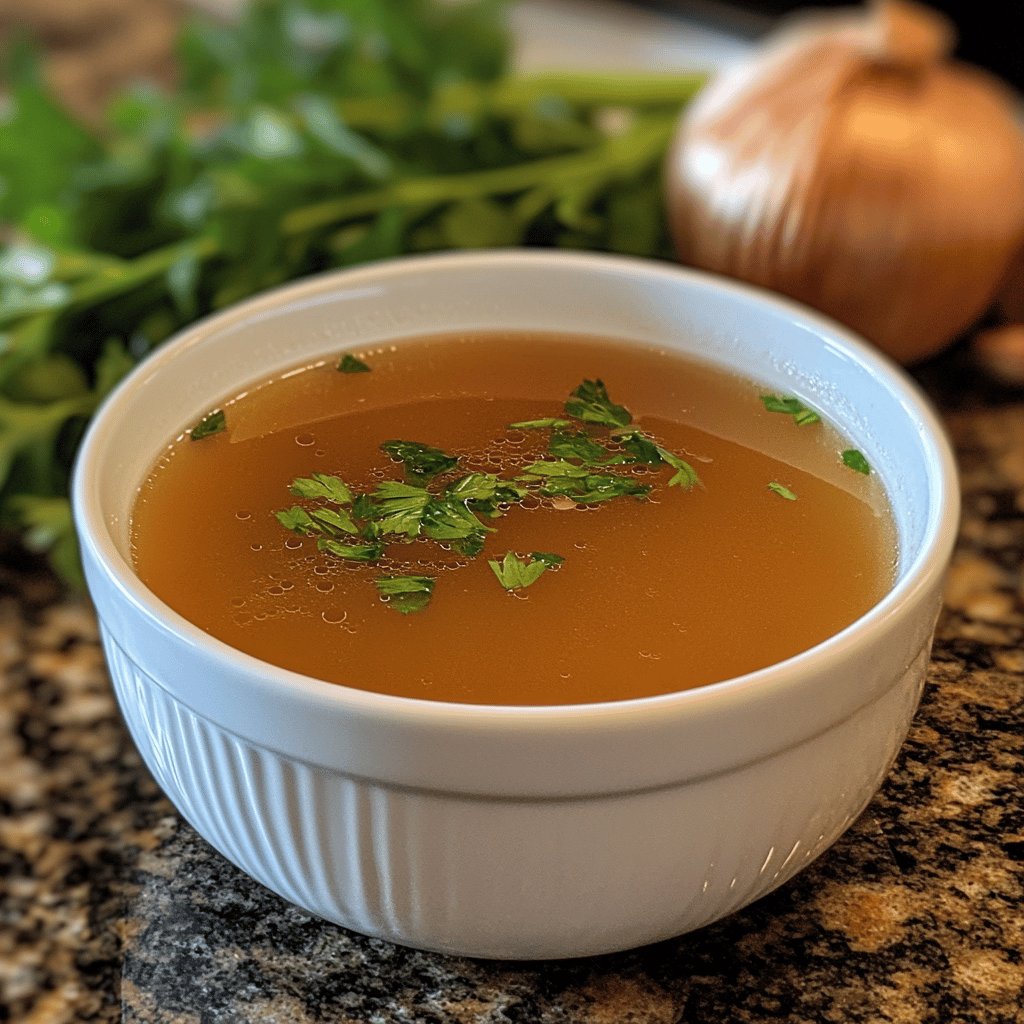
xmin=72 ymin=249 xmax=959 ymax=730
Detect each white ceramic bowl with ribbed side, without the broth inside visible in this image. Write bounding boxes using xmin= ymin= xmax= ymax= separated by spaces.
xmin=74 ymin=251 xmax=958 ymax=958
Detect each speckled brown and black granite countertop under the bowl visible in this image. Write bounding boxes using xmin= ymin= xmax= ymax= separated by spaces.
xmin=0 ymin=361 xmax=1024 ymax=1024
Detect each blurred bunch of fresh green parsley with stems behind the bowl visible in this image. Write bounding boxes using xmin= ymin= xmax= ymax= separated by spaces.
xmin=0 ymin=0 xmax=701 ymax=580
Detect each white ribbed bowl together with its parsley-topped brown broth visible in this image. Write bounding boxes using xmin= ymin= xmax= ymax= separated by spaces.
xmin=74 ymin=252 xmax=957 ymax=958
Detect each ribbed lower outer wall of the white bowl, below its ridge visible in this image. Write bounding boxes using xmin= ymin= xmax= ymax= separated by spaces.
xmin=103 ymin=614 xmax=928 ymax=958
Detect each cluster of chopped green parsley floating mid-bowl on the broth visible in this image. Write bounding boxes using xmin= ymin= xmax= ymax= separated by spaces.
xmin=274 ymin=380 xmax=716 ymax=614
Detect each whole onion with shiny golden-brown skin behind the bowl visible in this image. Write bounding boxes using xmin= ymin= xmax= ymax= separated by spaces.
xmin=666 ymin=2 xmax=1024 ymax=362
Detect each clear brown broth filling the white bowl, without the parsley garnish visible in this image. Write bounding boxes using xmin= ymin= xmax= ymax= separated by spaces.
xmin=132 ymin=333 xmax=896 ymax=705
